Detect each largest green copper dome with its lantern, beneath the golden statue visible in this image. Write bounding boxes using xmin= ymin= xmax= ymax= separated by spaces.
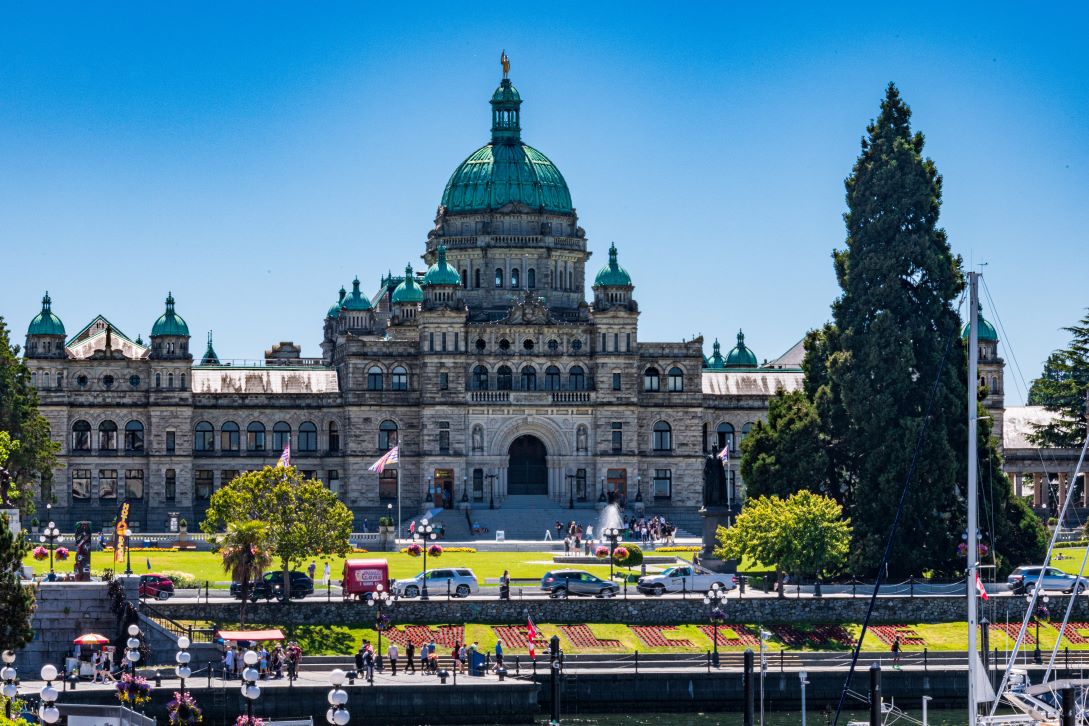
xmin=442 ymin=78 xmax=573 ymax=214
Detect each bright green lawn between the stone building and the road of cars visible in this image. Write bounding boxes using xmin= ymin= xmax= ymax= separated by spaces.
xmin=23 ymin=551 xmax=656 ymax=587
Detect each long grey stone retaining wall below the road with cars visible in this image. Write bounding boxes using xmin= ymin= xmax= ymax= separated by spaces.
xmin=156 ymin=594 xmax=1089 ymax=625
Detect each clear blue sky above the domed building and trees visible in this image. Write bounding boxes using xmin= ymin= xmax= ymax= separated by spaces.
xmin=0 ymin=2 xmax=1089 ymax=402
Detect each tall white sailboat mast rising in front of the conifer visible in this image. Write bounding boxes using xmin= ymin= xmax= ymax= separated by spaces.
xmin=966 ymin=272 xmax=979 ymax=726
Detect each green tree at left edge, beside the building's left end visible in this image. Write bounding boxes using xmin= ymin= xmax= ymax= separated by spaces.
xmin=0 ymin=317 xmax=60 ymax=514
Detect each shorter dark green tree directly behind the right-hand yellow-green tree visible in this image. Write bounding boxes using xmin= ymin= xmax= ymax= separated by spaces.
xmin=741 ymin=391 xmax=828 ymax=496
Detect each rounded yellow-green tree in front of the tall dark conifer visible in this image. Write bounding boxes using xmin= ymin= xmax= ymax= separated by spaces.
xmin=714 ymin=490 xmax=851 ymax=596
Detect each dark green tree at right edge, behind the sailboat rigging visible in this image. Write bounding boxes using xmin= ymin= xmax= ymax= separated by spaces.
xmin=1029 ymin=315 xmax=1089 ymax=448
